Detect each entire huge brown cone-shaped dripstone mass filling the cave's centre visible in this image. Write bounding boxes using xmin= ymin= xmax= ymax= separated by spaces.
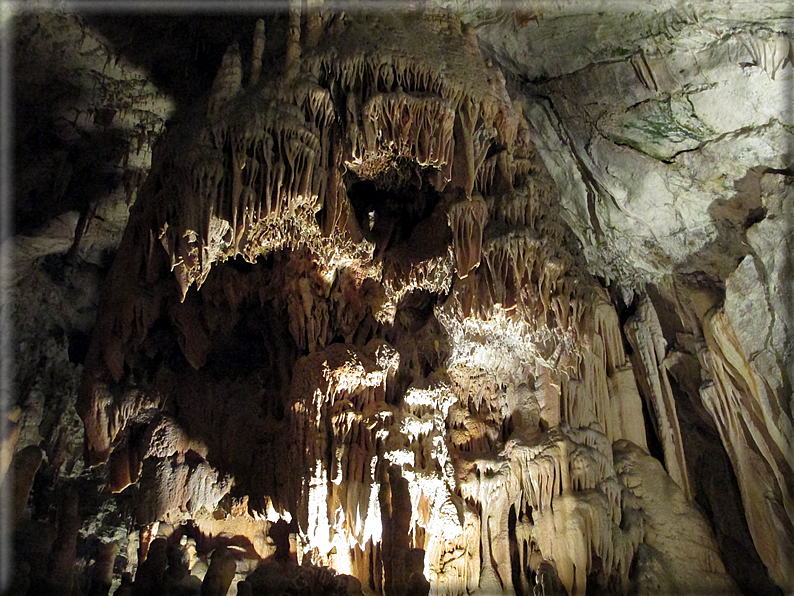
xmin=69 ymin=12 xmax=744 ymax=594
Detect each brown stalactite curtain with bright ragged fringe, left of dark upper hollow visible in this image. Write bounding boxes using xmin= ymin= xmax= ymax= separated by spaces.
xmin=149 ymin=24 xmax=358 ymax=298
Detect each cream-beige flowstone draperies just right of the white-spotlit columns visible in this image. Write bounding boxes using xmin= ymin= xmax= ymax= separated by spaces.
xmin=436 ymin=272 xmax=645 ymax=594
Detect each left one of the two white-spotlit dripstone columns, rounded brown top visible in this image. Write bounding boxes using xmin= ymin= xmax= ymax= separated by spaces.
xmin=289 ymin=340 xmax=399 ymax=555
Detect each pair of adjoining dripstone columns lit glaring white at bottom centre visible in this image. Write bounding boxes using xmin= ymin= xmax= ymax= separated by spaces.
xmin=287 ymin=340 xmax=462 ymax=590
